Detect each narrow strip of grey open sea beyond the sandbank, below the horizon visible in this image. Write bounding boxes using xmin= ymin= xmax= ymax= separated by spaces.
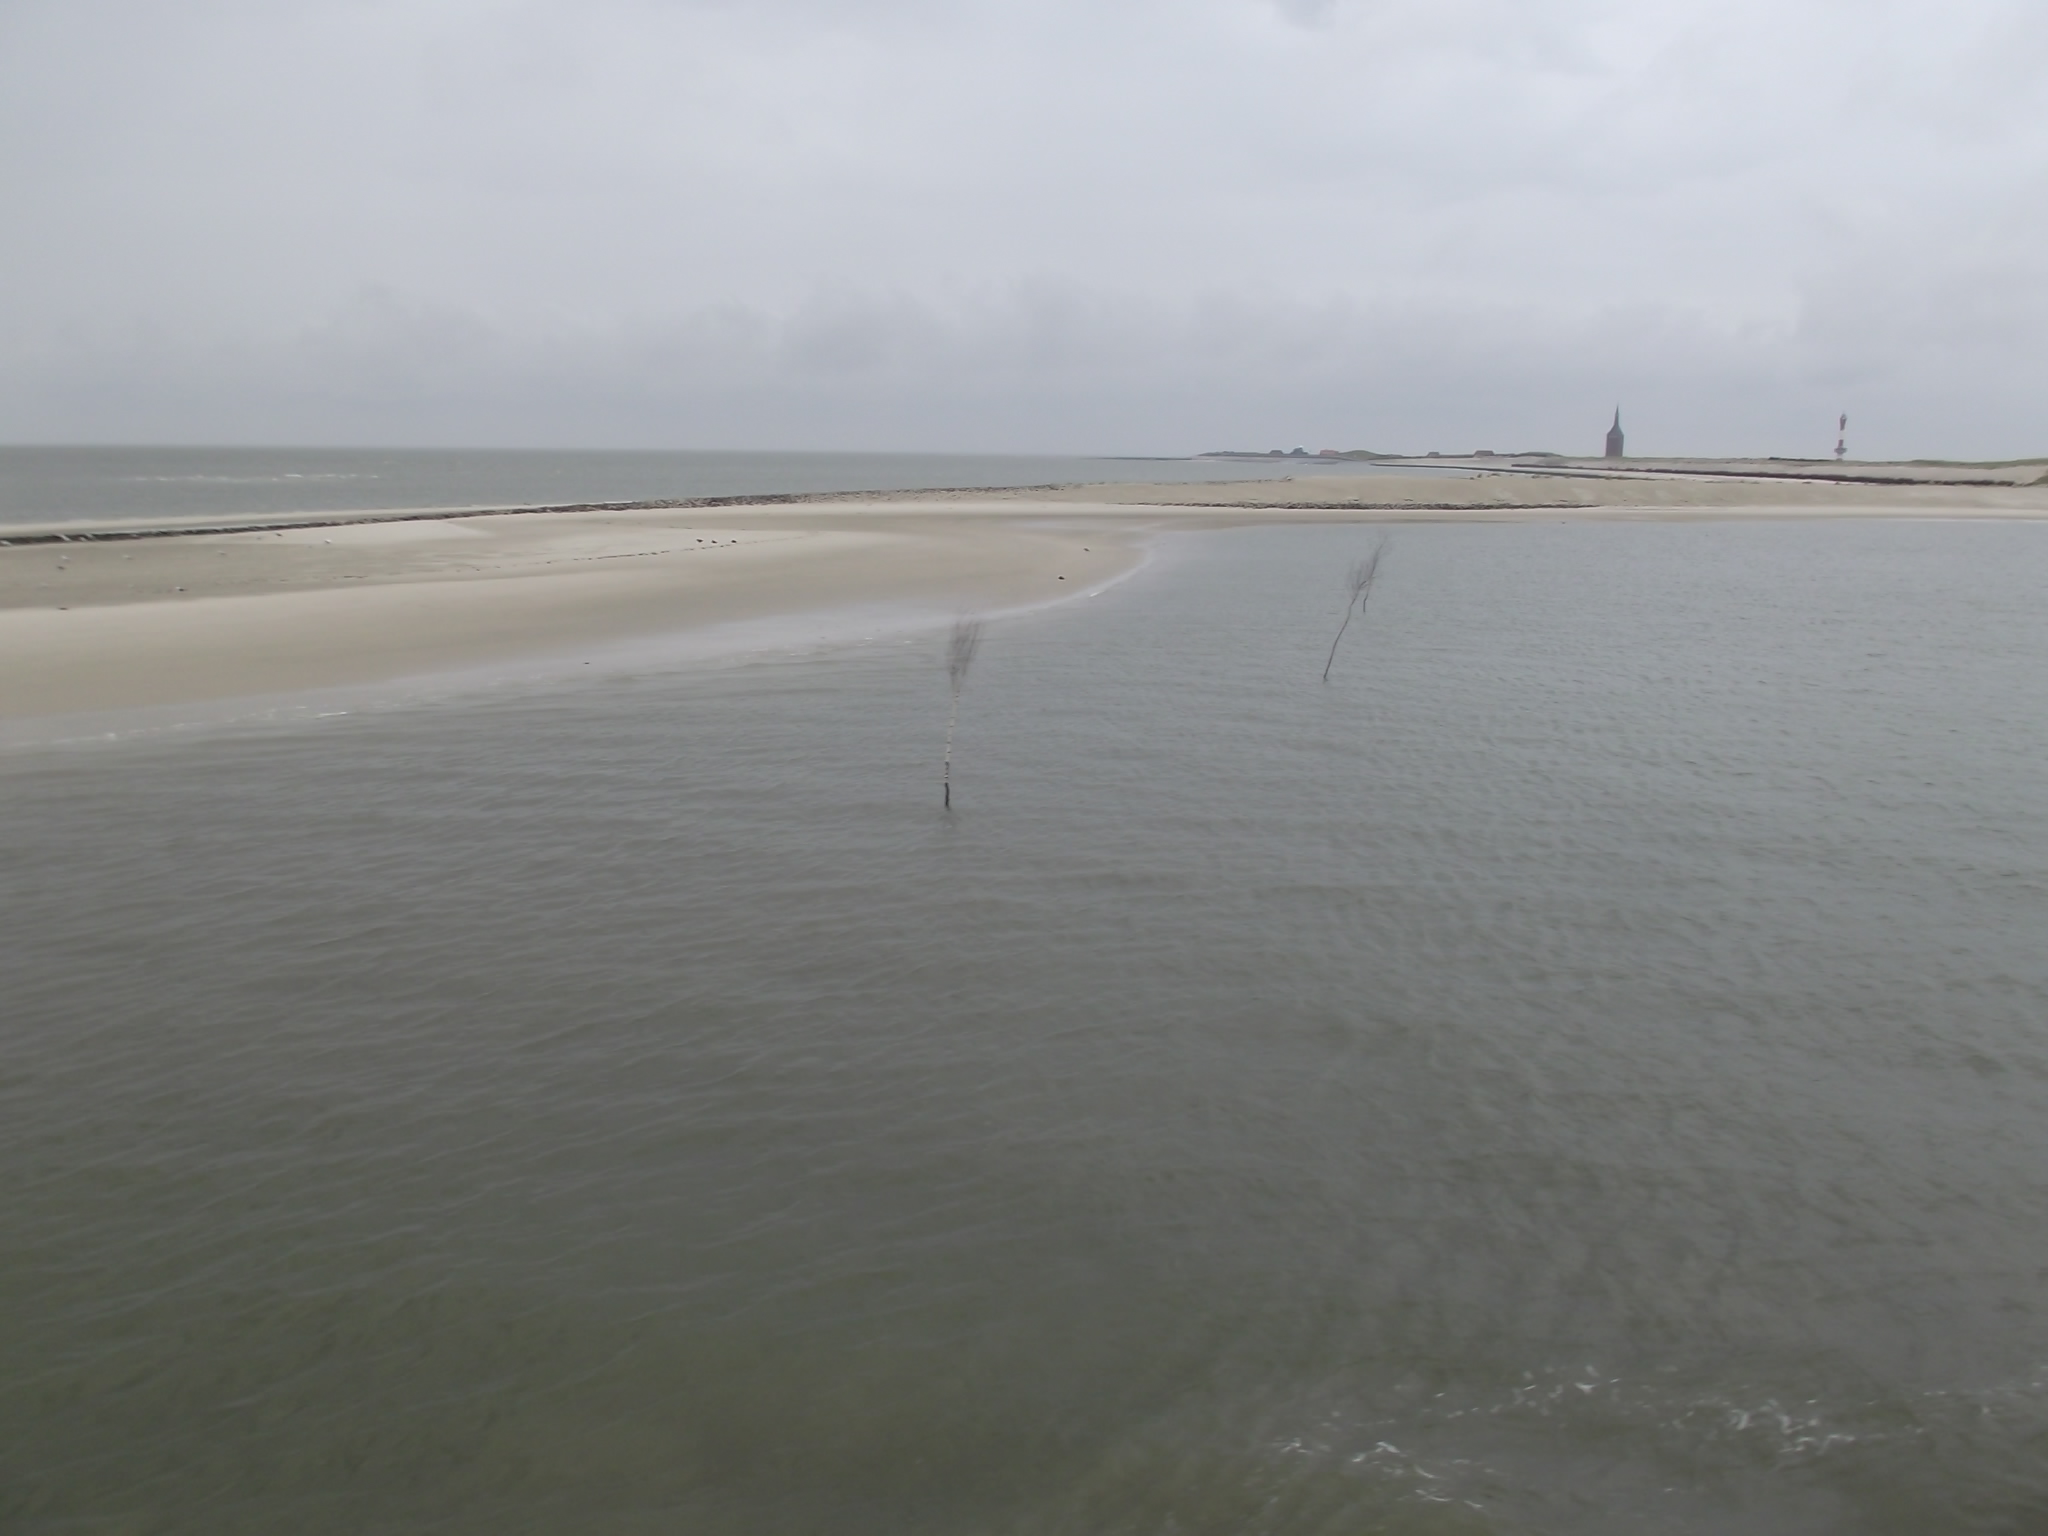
xmin=0 ymin=444 xmax=1376 ymax=526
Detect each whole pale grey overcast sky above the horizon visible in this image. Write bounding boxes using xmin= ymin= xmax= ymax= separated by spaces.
xmin=0 ymin=0 xmax=2048 ymax=457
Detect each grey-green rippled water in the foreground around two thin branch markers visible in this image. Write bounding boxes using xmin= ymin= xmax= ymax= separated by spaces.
xmin=0 ymin=522 xmax=2048 ymax=1536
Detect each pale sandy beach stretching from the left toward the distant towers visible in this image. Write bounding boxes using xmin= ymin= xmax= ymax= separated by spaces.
xmin=12 ymin=467 xmax=2048 ymax=721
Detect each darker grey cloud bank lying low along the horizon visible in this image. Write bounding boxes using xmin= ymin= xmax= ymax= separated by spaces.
xmin=0 ymin=281 xmax=2032 ymax=455
